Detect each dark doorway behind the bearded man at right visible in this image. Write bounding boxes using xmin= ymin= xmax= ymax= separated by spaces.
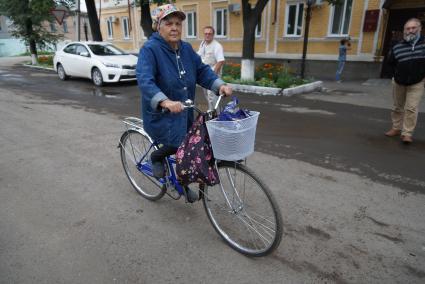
xmin=381 ymin=7 xmax=425 ymax=78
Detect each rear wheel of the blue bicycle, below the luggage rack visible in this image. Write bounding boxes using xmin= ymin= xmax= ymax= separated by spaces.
xmin=120 ymin=129 xmax=166 ymax=201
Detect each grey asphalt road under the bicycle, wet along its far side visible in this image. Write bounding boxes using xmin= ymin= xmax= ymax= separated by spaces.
xmin=0 ymin=62 xmax=425 ymax=283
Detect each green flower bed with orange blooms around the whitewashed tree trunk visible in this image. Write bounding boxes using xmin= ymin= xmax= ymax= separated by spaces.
xmin=222 ymin=63 xmax=310 ymax=89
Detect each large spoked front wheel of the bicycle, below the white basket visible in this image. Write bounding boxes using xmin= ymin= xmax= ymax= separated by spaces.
xmin=203 ymin=161 xmax=282 ymax=256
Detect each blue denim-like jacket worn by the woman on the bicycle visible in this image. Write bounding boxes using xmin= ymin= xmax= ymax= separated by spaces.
xmin=136 ymin=33 xmax=224 ymax=147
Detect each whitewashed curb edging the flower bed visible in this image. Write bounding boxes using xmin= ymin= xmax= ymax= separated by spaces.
xmin=229 ymin=81 xmax=323 ymax=97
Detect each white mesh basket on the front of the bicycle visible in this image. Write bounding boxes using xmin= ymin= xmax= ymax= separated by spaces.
xmin=206 ymin=111 xmax=260 ymax=161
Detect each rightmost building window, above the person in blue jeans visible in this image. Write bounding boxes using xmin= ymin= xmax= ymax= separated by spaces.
xmin=330 ymin=0 xmax=353 ymax=35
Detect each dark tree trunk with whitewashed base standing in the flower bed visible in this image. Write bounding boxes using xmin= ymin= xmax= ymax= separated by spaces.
xmin=241 ymin=0 xmax=268 ymax=80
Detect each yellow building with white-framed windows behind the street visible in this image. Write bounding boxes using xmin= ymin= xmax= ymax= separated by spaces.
xmin=96 ymin=0 xmax=425 ymax=79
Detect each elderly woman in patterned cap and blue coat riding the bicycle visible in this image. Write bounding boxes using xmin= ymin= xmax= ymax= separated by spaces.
xmin=136 ymin=4 xmax=232 ymax=201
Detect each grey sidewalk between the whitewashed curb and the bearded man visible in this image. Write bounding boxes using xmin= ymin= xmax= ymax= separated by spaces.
xmin=303 ymin=79 xmax=425 ymax=112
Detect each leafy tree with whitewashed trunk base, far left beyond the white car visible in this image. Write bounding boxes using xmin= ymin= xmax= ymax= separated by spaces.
xmin=0 ymin=0 xmax=68 ymax=64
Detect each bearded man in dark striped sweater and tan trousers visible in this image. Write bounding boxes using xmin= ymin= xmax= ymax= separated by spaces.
xmin=385 ymin=18 xmax=425 ymax=144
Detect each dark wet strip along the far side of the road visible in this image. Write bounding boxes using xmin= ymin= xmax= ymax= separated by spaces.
xmin=0 ymin=66 xmax=425 ymax=193
